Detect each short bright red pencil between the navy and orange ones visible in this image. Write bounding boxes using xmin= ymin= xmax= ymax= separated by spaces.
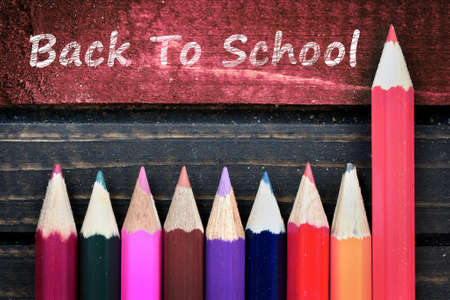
xmin=287 ymin=163 xmax=330 ymax=300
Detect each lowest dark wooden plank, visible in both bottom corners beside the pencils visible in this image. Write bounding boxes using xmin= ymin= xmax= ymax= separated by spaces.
xmin=0 ymin=245 xmax=450 ymax=299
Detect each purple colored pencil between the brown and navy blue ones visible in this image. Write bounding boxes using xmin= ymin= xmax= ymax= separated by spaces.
xmin=205 ymin=167 xmax=245 ymax=300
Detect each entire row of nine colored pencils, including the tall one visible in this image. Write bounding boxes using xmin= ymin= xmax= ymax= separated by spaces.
xmin=35 ymin=25 xmax=415 ymax=300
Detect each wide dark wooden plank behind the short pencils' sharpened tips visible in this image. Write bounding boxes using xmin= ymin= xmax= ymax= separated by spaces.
xmin=0 ymin=118 xmax=450 ymax=233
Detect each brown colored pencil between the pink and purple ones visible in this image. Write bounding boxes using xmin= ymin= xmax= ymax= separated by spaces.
xmin=163 ymin=167 xmax=205 ymax=300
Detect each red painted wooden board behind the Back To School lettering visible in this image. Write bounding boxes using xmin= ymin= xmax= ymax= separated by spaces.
xmin=0 ymin=0 xmax=450 ymax=105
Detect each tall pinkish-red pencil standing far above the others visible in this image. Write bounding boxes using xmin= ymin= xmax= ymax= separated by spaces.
xmin=372 ymin=25 xmax=415 ymax=300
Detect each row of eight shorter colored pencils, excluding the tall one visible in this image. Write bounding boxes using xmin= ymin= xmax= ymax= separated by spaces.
xmin=35 ymin=163 xmax=372 ymax=300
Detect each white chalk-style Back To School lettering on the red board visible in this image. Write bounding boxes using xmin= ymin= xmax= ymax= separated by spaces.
xmin=30 ymin=29 xmax=360 ymax=68
